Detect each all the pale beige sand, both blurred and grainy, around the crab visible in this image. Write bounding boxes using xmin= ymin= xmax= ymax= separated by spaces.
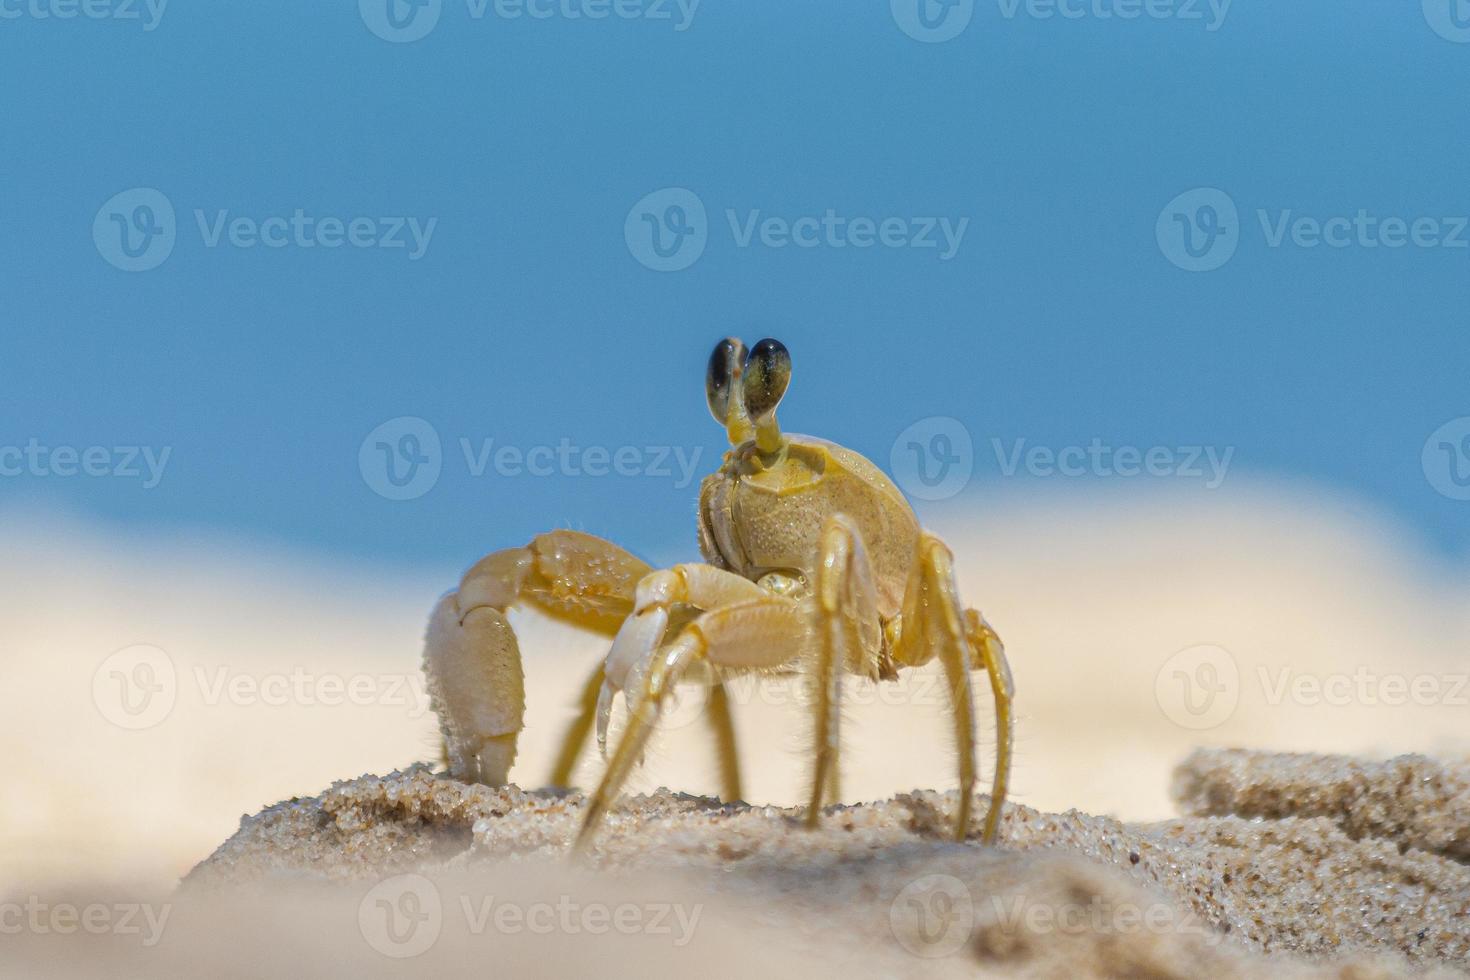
xmin=11 ymin=505 xmax=1470 ymax=980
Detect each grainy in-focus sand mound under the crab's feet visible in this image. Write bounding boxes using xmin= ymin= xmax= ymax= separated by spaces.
xmin=117 ymin=751 xmax=1470 ymax=977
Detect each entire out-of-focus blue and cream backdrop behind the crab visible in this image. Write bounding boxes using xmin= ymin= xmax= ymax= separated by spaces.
xmin=0 ymin=0 xmax=1470 ymax=884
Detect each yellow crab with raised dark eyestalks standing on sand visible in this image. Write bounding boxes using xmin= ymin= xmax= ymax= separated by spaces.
xmin=423 ymin=338 xmax=1014 ymax=849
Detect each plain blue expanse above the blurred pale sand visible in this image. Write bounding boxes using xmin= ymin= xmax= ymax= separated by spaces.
xmin=0 ymin=0 xmax=1470 ymax=567
